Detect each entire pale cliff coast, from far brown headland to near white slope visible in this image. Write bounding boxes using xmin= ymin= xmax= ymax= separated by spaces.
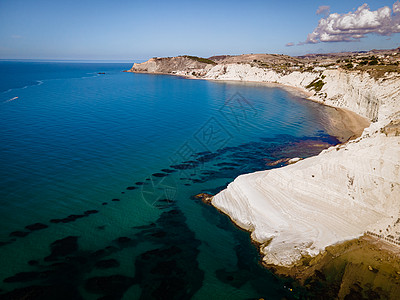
xmin=131 ymin=58 xmax=400 ymax=267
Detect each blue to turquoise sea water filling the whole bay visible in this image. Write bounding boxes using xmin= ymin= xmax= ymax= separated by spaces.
xmin=0 ymin=62 xmax=337 ymax=299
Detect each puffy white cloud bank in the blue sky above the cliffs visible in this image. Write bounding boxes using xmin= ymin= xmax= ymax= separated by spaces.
xmin=300 ymin=0 xmax=400 ymax=45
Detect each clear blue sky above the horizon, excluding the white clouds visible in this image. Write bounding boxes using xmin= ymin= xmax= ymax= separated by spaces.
xmin=0 ymin=0 xmax=400 ymax=60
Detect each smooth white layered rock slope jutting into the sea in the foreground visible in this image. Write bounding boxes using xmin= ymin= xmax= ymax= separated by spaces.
xmin=212 ymin=133 xmax=400 ymax=266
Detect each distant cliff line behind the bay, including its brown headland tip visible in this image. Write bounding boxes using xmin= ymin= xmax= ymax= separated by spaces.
xmin=129 ymin=56 xmax=400 ymax=122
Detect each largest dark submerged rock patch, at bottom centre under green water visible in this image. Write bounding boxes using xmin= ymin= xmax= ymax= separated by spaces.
xmin=135 ymin=203 xmax=204 ymax=299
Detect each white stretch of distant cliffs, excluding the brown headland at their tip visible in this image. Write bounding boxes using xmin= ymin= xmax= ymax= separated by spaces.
xmin=204 ymin=64 xmax=400 ymax=121
